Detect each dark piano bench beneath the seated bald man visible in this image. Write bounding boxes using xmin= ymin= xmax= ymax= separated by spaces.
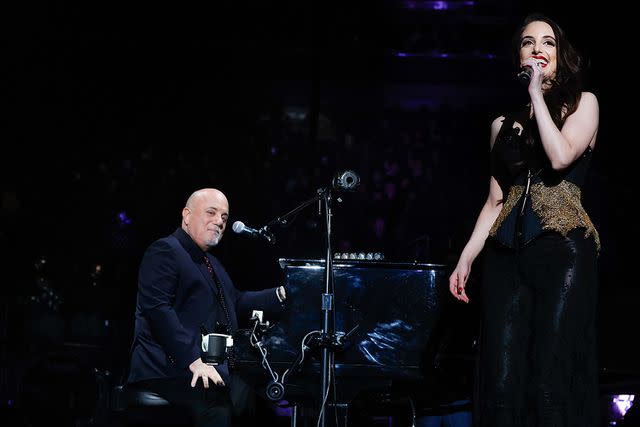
xmin=110 ymin=384 xmax=192 ymax=427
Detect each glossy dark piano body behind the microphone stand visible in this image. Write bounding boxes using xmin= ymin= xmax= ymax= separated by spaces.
xmin=235 ymin=259 xmax=448 ymax=406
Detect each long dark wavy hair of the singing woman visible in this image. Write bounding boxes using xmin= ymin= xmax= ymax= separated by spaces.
xmin=511 ymin=13 xmax=582 ymax=128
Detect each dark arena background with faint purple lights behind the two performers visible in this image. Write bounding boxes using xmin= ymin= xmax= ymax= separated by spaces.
xmin=0 ymin=0 xmax=639 ymax=424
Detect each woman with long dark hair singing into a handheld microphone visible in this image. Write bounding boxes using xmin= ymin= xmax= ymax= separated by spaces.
xmin=449 ymin=14 xmax=600 ymax=427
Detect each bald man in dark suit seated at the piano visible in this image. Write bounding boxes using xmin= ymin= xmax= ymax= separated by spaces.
xmin=127 ymin=188 xmax=286 ymax=426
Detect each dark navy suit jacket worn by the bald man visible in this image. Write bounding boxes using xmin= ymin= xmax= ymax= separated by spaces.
xmin=127 ymin=228 xmax=281 ymax=383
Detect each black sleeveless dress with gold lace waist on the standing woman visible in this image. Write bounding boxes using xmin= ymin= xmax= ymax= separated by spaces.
xmin=474 ymin=114 xmax=600 ymax=427
